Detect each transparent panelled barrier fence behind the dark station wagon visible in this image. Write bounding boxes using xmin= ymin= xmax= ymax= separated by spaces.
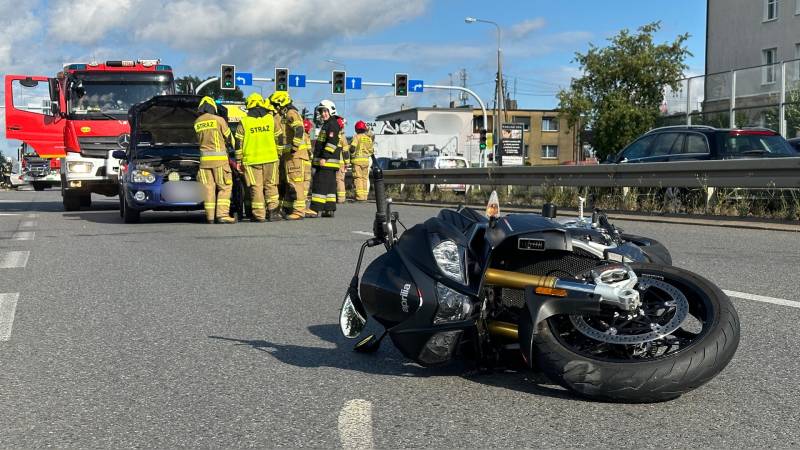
xmin=658 ymin=59 xmax=800 ymax=138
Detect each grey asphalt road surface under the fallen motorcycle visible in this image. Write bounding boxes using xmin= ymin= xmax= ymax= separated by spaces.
xmin=0 ymin=191 xmax=800 ymax=448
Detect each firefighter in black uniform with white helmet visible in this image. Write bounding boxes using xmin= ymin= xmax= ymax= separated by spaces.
xmin=311 ymin=100 xmax=342 ymax=217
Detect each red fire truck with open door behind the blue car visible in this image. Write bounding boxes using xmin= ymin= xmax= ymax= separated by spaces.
xmin=5 ymin=60 xmax=175 ymax=211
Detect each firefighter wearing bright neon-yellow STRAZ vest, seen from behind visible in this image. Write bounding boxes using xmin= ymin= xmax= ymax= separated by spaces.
xmin=231 ymin=92 xmax=281 ymax=222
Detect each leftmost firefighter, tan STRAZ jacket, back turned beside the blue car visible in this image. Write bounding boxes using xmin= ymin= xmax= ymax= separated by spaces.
xmin=194 ymin=97 xmax=236 ymax=223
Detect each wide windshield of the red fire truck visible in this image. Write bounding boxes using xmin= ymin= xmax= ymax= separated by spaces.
xmin=69 ymin=72 xmax=174 ymax=120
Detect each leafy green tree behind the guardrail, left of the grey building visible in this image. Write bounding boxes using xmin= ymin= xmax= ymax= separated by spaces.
xmin=558 ymin=22 xmax=691 ymax=158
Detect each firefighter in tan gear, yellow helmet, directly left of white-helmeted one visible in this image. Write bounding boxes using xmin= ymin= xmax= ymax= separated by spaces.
xmin=269 ymin=91 xmax=311 ymax=220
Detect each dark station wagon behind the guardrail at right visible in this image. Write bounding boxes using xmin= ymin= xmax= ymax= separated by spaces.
xmin=605 ymin=126 xmax=798 ymax=163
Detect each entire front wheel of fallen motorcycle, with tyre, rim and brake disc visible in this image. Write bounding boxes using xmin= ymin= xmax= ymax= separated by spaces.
xmin=530 ymin=264 xmax=739 ymax=403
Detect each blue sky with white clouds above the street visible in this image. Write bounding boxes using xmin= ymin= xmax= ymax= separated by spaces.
xmin=0 ymin=0 xmax=706 ymax=155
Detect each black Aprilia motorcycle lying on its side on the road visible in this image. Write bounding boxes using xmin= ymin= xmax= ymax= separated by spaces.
xmin=340 ymin=156 xmax=739 ymax=402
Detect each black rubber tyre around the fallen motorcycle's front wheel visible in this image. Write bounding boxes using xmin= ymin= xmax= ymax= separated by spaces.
xmin=523 ymin=264 xmax=740 ymax=403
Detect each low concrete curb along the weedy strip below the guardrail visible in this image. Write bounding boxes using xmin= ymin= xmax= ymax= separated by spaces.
xmin=392 ymin=201 xmax=800 ymax=233
